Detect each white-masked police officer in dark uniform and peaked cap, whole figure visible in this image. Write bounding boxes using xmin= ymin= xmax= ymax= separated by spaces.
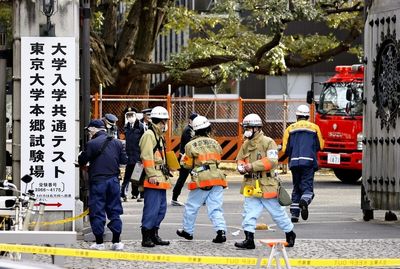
xmin=121 ymin=107 xmax=144 ymax=202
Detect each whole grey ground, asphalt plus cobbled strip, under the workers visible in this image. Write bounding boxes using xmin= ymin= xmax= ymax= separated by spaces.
xmin=33 ymin=172 xmax=400 ymax=269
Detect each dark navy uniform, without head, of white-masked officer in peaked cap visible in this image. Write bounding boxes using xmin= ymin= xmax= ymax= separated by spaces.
xmin=121 ymin=120 xmax=144 ymax=198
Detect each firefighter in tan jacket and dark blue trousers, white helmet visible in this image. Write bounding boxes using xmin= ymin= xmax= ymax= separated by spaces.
xmin=139 ymin=106 xmax=171 ymax=247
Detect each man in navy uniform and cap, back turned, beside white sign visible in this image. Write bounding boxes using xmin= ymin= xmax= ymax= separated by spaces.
xmin=78 ymin=120 xmax=128 ymax=250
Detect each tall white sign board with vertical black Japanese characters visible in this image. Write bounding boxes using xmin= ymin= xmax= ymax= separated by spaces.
xmin=21 ymin=37 xmax=77 ymax=210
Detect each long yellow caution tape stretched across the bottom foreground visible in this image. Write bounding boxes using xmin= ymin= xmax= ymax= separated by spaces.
xmin=0 ymin=244 xmax=400 ymax=267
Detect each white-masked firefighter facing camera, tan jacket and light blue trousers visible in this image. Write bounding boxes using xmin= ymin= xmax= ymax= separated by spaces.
xmin=235 ymin=114 xmax=296 ymax=249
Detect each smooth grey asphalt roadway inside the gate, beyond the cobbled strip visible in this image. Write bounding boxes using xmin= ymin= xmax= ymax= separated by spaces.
xmin=117 ymin=175 xmax=400 ymax=240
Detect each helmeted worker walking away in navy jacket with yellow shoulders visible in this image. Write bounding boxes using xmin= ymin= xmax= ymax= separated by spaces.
xmin=280 ymin=105 xmax=324 ymax=223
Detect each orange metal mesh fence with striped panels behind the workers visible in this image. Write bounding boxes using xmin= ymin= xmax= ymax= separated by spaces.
xmin=92 ymin=95 xmax=305 ymax=160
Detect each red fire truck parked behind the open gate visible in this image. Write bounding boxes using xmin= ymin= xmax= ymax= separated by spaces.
xmin=307 ymin=65 xmax=364 ymax=183
